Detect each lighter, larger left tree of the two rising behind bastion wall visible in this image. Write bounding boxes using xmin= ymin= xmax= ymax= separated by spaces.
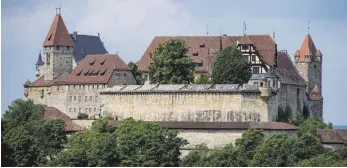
xmin=149 ymin=39 xmax=196 ymax=84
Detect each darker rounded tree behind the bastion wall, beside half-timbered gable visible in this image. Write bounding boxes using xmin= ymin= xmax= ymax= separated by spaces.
xmin=212 ymin=46 xmax=252 ymax=84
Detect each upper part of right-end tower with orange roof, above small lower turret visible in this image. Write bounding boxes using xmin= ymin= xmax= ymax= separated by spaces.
xmin=294 ymin=34 xmax=322 ymax=93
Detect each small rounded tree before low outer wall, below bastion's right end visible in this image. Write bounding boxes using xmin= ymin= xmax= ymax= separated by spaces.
xmin=235 ymin=129 xmax=264 ymax=163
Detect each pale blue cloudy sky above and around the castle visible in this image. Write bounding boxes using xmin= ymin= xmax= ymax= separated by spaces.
xmin=1 ymin=0 xmax=347 ymax=125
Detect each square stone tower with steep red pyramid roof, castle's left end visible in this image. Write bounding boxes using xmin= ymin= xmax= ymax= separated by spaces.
xmin=43 ymin=13 xmax=74 ymax=80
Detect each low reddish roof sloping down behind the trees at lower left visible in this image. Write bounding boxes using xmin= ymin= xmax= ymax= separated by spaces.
xmin=43 ymin=107 xmax=84 ymax=132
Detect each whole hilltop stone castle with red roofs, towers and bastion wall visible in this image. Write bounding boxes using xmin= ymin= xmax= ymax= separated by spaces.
xmin=24 ymin=13 xmax=323 ymax=122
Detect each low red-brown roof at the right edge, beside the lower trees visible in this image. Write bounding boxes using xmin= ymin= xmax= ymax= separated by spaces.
xmin=317 ymin=129 xmax=347 ymax=144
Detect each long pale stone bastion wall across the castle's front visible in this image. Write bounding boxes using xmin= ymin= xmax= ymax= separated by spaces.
xmin=102 ymin=85 xmax=273 ymax=122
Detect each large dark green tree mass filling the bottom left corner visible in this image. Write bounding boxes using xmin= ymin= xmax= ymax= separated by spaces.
xmin=1 ymin=99 xmax=66 ymax=166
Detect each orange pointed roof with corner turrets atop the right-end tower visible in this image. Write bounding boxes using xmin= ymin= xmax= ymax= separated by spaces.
xmin=295 ymin=34 xmax=320 ymax=62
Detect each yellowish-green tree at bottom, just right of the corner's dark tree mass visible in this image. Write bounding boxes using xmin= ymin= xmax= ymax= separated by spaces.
xmin=48 ymin=119 xmax=119 ymax=167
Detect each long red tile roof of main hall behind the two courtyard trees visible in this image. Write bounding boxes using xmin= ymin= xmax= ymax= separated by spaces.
xmin=138 ymin=35 xmax=305 ymax=85
